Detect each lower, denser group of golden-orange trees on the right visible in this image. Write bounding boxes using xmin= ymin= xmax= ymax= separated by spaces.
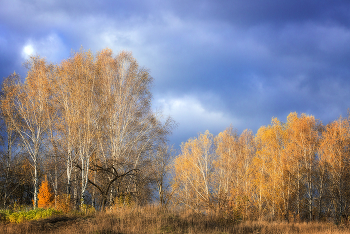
xmin=172 ymin=113 xmax=350 ymax=222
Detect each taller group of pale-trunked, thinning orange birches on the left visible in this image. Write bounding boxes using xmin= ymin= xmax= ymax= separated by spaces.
xmin=0 ymin=49 xmax=174 ymax=208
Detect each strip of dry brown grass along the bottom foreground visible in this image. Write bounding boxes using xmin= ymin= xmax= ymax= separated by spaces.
xmin=0 ymin=206 xmax=350 ymax=234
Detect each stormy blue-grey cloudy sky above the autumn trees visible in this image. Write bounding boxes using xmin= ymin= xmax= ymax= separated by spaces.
xmin=0 ymin=0 xmax=350 ymax=148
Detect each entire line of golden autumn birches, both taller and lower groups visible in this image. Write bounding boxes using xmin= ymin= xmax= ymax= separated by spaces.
xmin=0 ymin=46 xmax=350 ymax=221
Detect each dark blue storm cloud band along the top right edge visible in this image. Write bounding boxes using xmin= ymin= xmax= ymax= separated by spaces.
xmin=165 ymin=0 xmax=350 ymax=27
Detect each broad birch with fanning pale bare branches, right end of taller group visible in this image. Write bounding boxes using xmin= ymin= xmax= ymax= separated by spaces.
xmin=96 ymin=50 xmax=160 ymax=204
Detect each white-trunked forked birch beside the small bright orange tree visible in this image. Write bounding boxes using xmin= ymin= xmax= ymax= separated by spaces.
xmin=2 ymin=57 xmax=52 ymax=207
